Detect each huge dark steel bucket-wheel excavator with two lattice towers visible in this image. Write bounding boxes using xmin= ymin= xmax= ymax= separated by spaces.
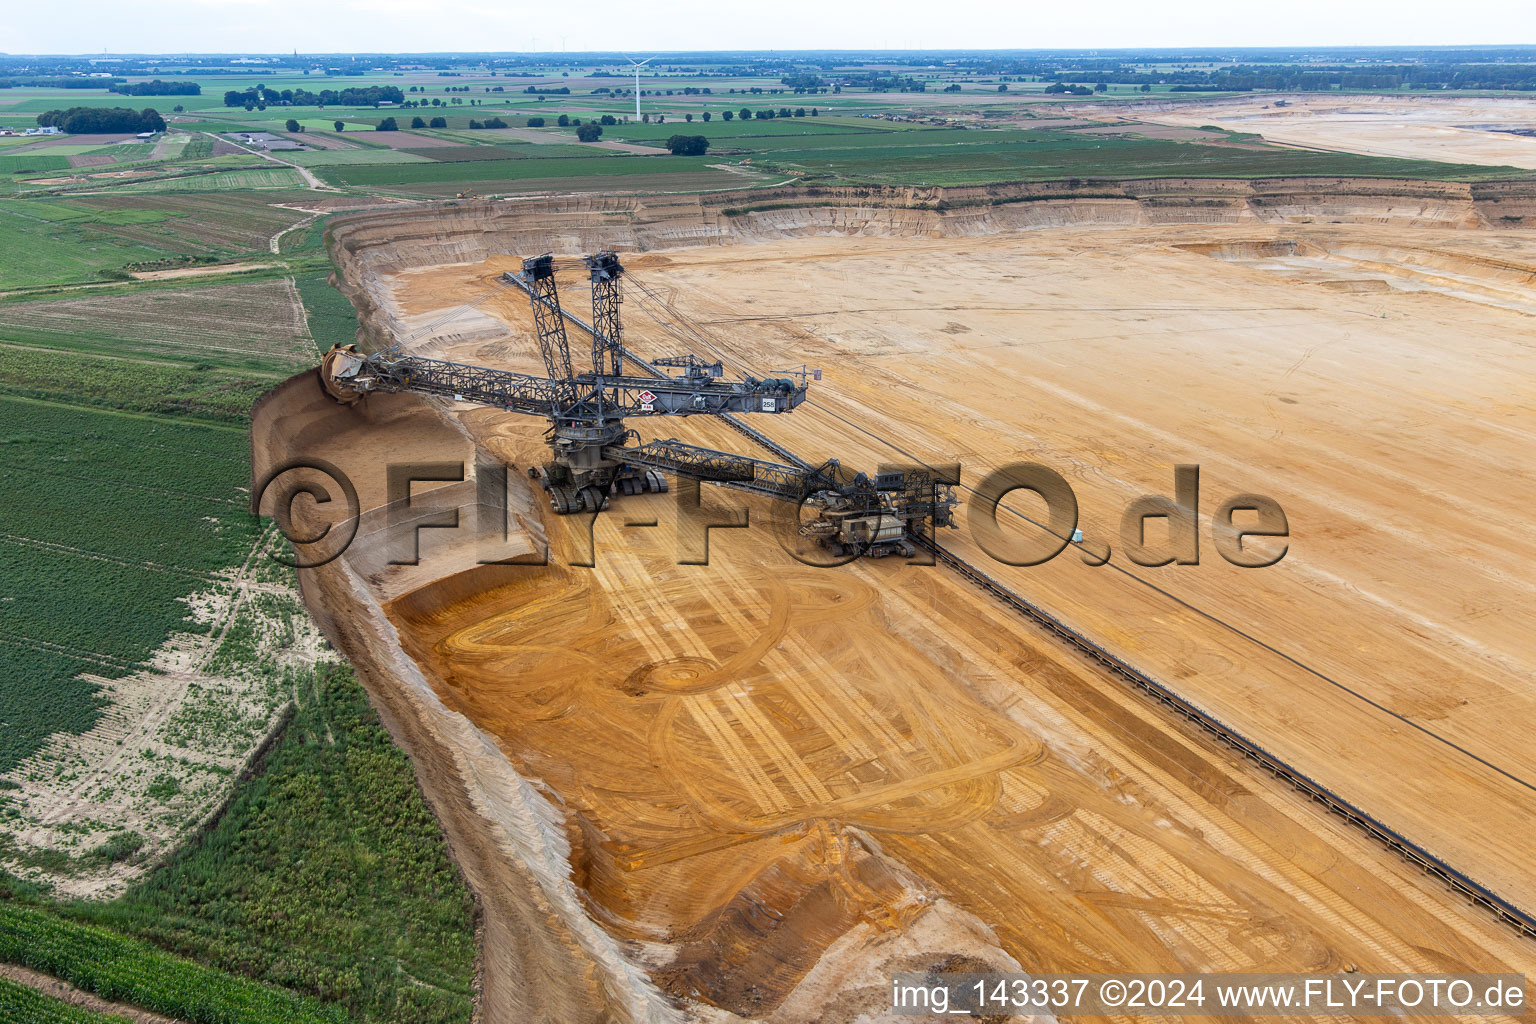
xmin=319 ymin=252 xmax=957 ymax=557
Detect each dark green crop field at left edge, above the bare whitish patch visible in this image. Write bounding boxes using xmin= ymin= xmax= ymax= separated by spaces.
xmin=0 ymin=396 xmax=260 ymax=771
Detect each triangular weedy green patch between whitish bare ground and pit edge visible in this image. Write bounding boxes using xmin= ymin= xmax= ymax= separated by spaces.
xmin=77 ymin=666 xmax=475 ymax=1024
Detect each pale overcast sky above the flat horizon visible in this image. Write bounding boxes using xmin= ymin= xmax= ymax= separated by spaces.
xmin=9 ymin=0 xmax=1536 ymax=54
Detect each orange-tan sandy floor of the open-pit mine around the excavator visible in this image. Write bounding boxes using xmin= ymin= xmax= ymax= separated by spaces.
xmin=257 ymin=186 xmax=1536 ymax=1021
